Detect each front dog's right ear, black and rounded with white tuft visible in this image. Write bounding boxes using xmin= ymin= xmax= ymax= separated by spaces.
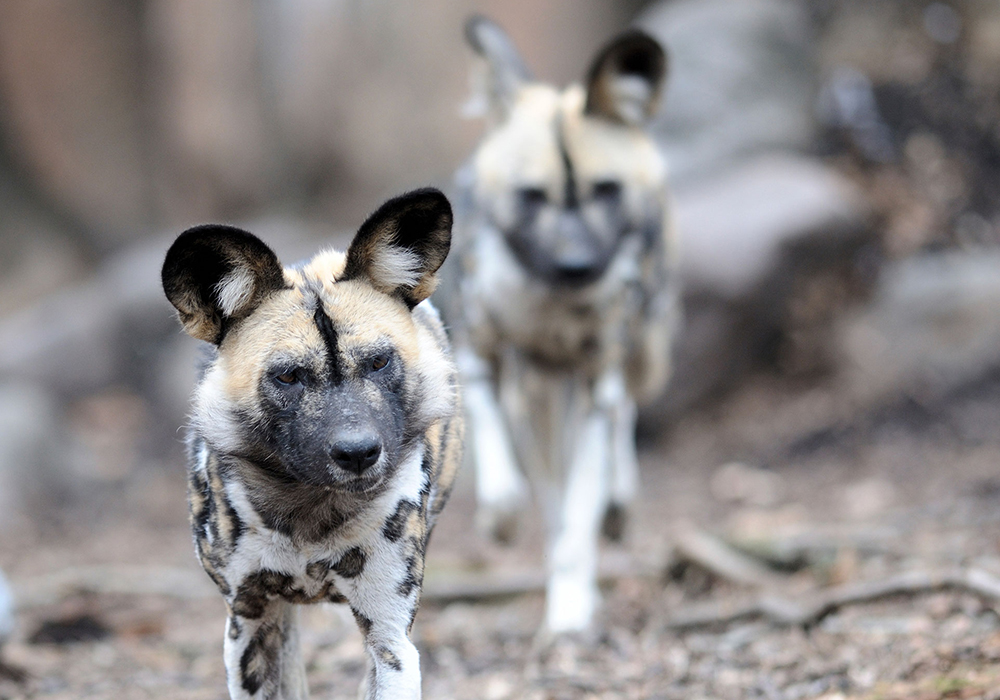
xmin=340 ymin=187 xmax=452 ymax=309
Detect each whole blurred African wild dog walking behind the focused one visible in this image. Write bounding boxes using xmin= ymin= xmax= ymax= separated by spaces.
xmin=449 ymin=17 xmax=677 ymax=632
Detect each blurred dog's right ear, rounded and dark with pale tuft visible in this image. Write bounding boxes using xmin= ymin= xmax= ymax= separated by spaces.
xmin=584 ymin=29 xmax=667 ymax=126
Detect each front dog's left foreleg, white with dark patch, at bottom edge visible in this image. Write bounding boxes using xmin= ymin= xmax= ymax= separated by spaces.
xmin=223 ymin=599 xmax=309 ymax=700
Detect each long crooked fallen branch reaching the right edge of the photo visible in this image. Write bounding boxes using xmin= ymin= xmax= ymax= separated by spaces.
xmin=666 ymin=569 xmax=1000 ymax=630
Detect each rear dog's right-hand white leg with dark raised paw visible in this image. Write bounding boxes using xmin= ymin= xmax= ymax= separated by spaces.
xmin=595 ymin=372 xmax=639 ymax=542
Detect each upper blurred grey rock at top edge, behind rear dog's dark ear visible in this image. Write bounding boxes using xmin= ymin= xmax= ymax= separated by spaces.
xmin=637 ymin=0 xmax=818 ymax=182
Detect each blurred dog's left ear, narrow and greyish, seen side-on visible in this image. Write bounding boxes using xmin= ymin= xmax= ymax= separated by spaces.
xmin=465 ymin=15 xmax=532 ymax=120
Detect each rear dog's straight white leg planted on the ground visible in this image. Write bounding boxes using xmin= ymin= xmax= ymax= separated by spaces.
xmin=545 ymin=408 xmax=611 ymax=633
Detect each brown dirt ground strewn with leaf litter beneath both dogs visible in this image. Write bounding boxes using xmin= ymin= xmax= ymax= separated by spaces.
xmin=0 ymin=360 xmax=1000 ymax=700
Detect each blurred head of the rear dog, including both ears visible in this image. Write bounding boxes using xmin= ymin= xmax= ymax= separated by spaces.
xmin=466 ymin=17 xmax=667 ymax=286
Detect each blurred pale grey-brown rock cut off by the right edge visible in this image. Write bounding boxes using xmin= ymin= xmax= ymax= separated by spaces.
xmin=837 ymin=251 xmax=1000 ymax=402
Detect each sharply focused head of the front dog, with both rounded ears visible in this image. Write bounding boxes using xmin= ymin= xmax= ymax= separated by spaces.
xmin=162 ymin=189 xmax=454 ymax=491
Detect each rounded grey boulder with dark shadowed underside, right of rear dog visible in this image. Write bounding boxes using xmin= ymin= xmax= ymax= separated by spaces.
xmin=641 ymin=154 xmax=872 ymax=432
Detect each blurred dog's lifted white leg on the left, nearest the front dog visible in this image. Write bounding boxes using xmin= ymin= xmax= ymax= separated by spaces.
xmin=456 ymin=349 xmax=528 ymax=542
